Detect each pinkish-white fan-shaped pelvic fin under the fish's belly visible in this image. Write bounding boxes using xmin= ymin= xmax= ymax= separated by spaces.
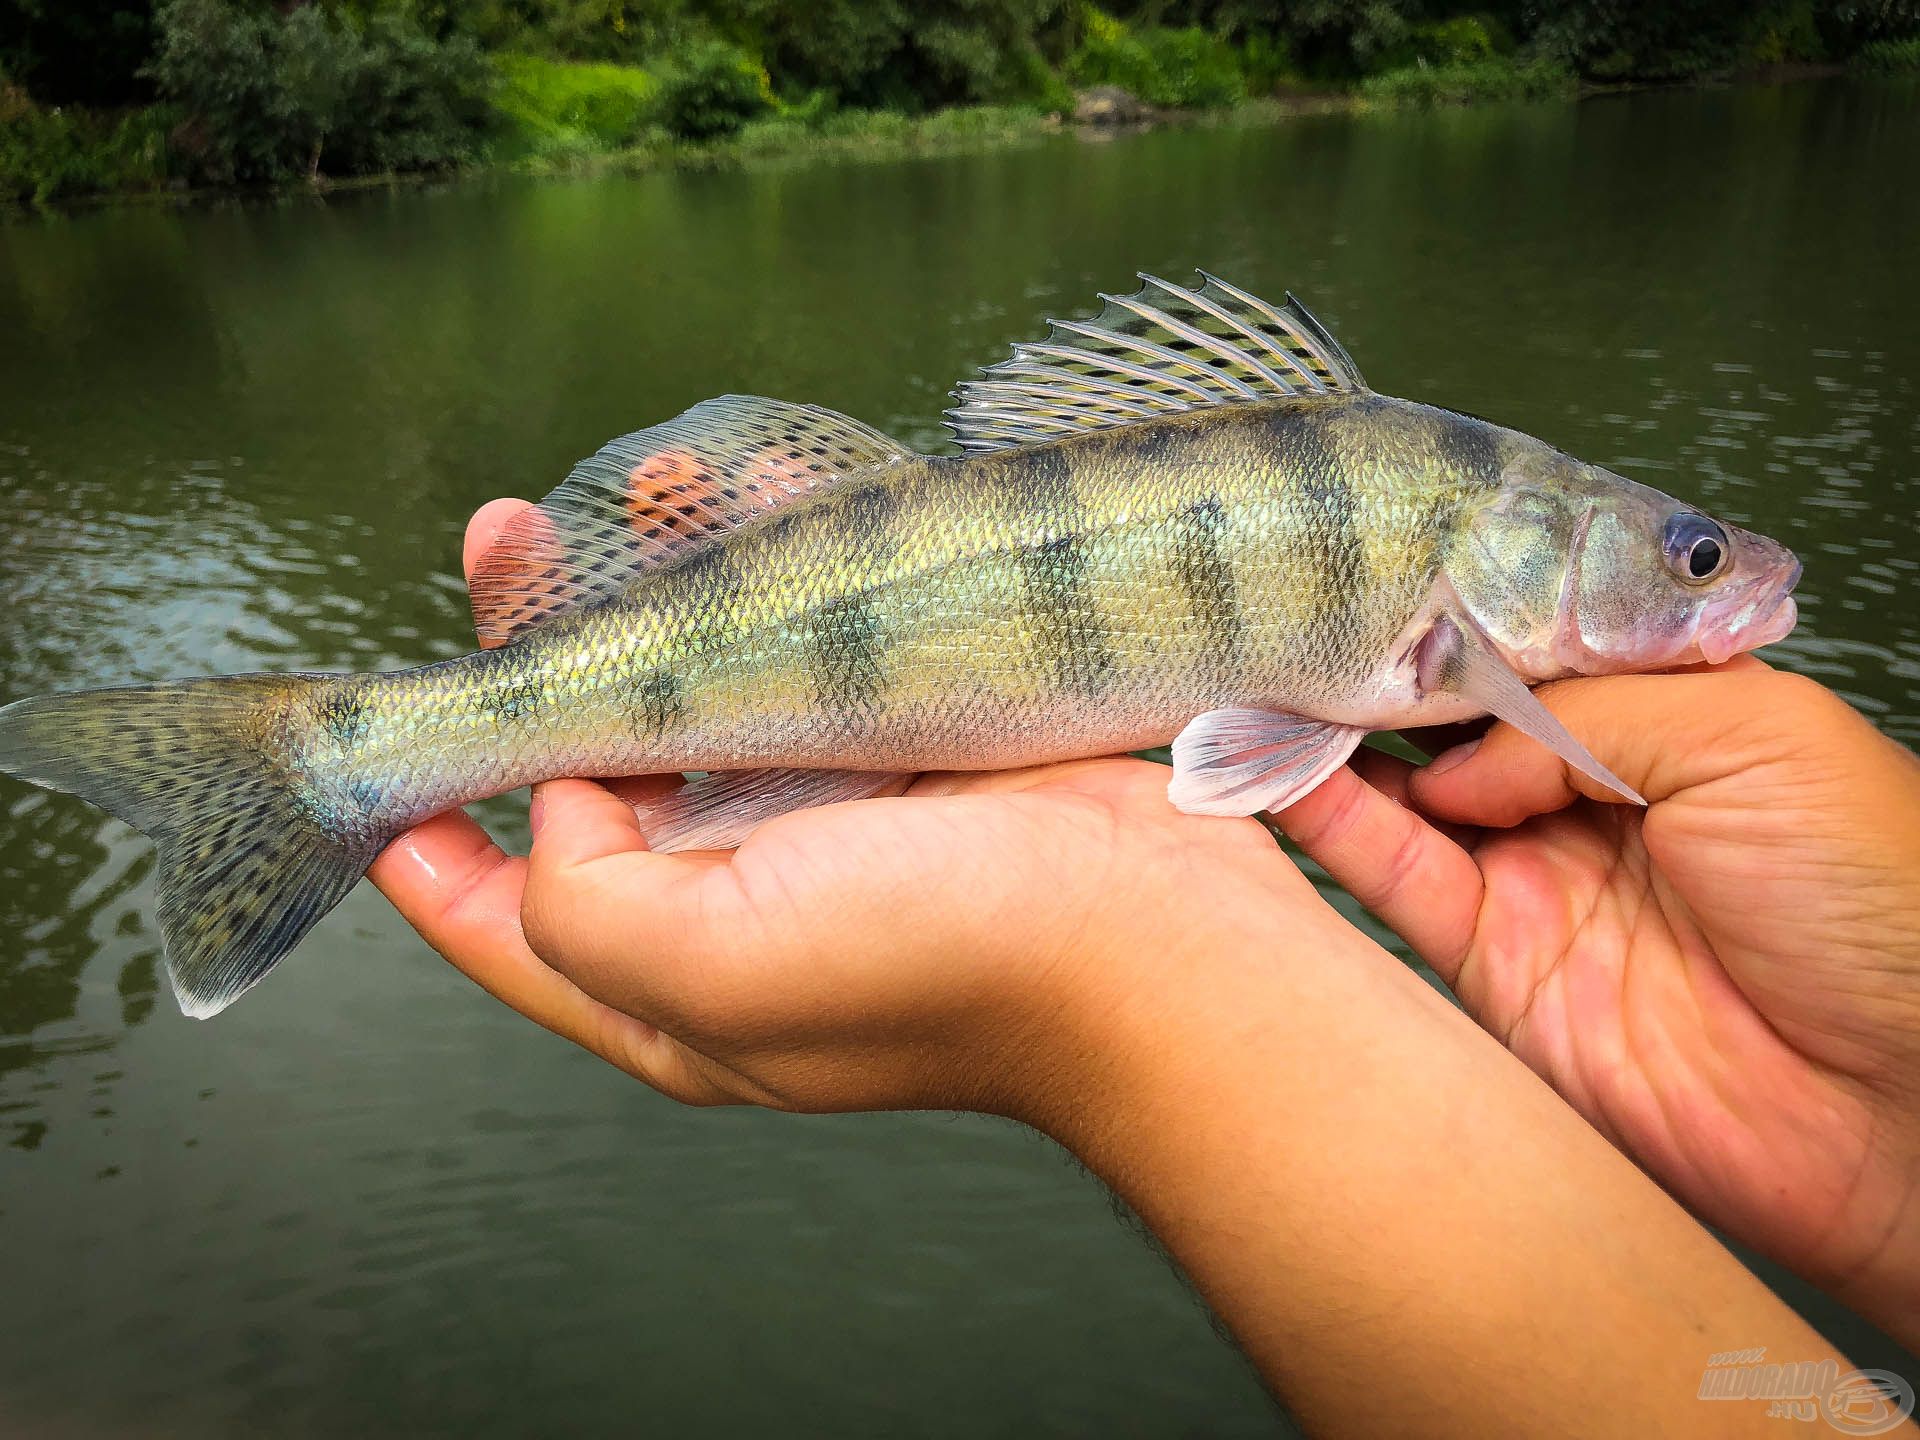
xmin=1167 ymin=710 xmax=1367 ymax=816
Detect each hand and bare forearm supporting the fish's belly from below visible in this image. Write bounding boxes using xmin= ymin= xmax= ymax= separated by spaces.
xmin=372 ymin=503 xmax=1858 ymax=1436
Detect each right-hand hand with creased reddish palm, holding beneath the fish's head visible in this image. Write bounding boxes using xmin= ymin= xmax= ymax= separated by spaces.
xmin=1279 ymin=659 xmax=1920 ymax=1344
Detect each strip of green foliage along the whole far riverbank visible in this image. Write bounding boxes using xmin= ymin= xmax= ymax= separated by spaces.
xmin=0 ymin=0 xmax=1920 ymax=198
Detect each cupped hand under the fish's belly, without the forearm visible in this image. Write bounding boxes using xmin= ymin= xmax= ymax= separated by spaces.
xmin=371 ymin=501 xmax=1313 ymax=1129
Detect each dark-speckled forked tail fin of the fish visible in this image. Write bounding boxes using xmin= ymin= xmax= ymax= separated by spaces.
xmin=0 ymin=676 xmax=386 ymax=1020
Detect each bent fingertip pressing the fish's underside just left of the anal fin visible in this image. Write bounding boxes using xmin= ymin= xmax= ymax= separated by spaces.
xmin=520 ymin=780 xmax=726 ymax=1033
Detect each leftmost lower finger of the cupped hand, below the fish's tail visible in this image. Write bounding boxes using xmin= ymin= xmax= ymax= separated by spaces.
xmin=367 ymin=810 xmax=701 ymax=1098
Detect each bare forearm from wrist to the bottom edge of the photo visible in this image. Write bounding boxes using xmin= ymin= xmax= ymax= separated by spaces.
xmin=1050 ymin=914 xmax=1832 ymax=1436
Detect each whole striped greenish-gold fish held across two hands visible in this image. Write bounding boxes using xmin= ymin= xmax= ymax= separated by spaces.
xmin=0 ymin=271 xmax=1801 ymax=1018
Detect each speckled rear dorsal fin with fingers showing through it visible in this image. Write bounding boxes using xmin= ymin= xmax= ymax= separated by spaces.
xmin=472 ymin=396 xmax=912 ymax=645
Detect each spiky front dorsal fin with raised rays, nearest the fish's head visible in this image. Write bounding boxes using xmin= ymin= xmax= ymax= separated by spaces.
xmin=947 ymin=271 xmax=1367 ymax=451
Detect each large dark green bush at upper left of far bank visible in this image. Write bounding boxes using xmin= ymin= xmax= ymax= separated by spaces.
xmin=150 ymin=0 xmax=492 ymax=184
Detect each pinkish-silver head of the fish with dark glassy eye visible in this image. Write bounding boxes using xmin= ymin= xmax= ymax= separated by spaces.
xmin=1448 ymin=451 xmax=1801 ymax=682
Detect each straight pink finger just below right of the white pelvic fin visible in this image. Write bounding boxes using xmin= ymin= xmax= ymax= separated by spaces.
xmin=1273 ymin=755 xmax=1480 ymax=985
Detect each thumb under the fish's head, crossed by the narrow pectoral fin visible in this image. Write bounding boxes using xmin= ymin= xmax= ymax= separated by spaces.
xmin=1407 ymin=657 xmax=1797 ymax=826
